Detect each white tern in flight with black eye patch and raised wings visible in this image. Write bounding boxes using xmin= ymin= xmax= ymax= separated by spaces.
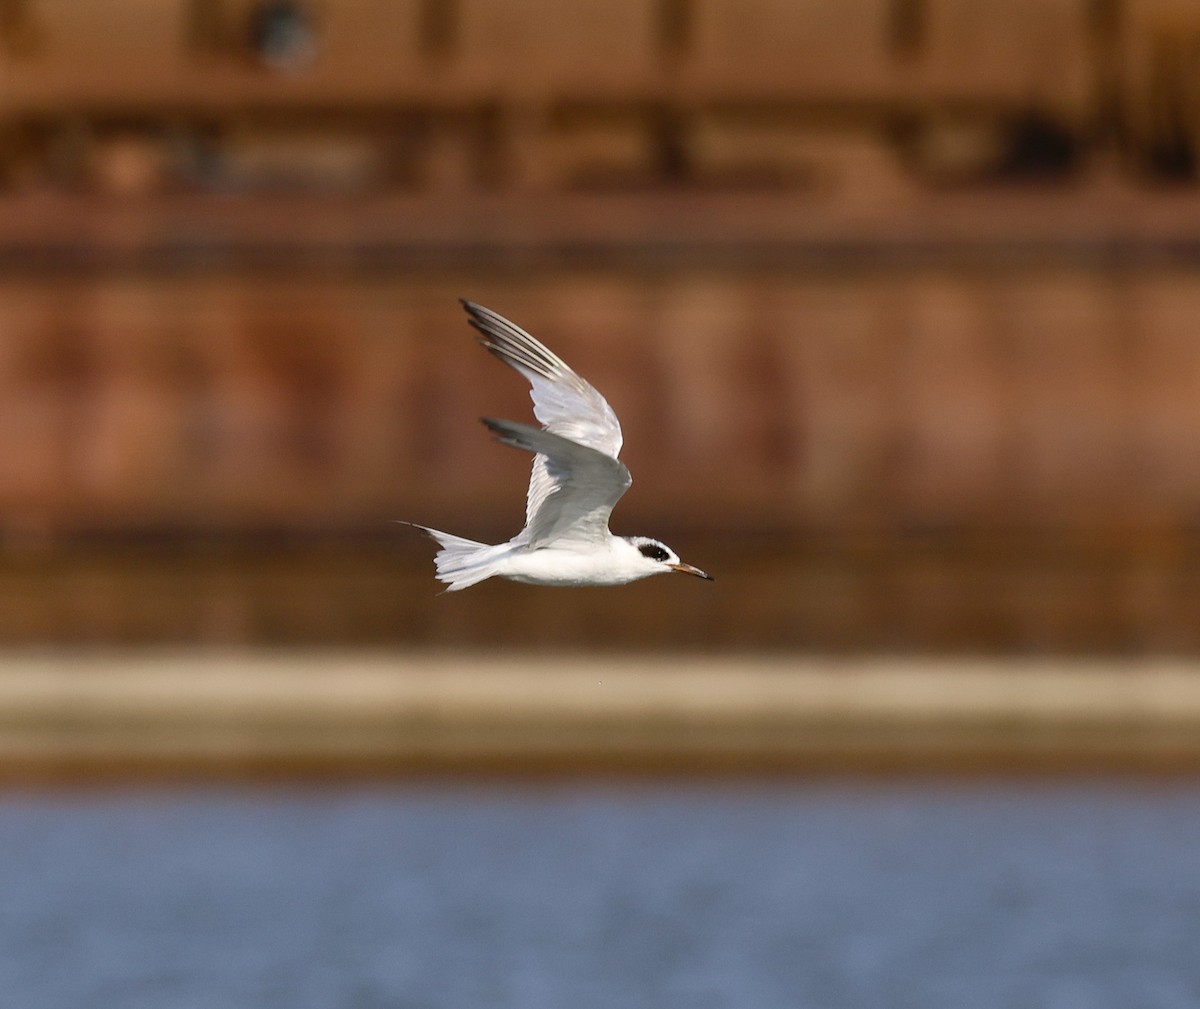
xmin=404 ymin=300 xmax=713 ymax=591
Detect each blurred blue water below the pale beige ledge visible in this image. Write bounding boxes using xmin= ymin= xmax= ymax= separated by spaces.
xmin=0 ymin=782 xmax=1200 ymax=1009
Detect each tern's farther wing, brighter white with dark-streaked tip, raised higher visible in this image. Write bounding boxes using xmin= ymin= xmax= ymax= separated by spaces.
xmin=462 ymin=301 xmax=629 ymax=529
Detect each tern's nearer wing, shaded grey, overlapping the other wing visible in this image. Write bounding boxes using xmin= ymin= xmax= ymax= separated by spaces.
xmin=484 ymin=418 xmax=632 ymax=547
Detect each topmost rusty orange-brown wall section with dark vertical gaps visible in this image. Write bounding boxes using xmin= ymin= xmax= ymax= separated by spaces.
xmin=0 ymin=0 xmax=1200 ymax=193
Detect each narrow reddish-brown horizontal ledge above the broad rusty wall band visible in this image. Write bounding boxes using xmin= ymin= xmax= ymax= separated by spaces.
xmin=7 ymin=182 xmax=1200 ymax=271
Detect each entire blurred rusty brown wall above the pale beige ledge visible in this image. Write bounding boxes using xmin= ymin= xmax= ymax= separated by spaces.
xmin=0 ymin=0 xmax=1200 ymax=654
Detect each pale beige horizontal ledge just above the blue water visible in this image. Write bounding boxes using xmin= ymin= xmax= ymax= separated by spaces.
xmin=0 ymin=651 xmax=1200 ymax=783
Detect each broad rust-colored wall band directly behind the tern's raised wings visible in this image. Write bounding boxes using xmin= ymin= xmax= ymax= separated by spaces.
xmin=0 ymin=268 xmax=1200 ymax=534
